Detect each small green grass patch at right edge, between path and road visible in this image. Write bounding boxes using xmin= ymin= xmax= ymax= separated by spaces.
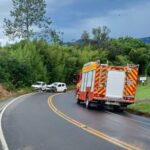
xmin=128 ymin=103 xmax=150 ymax=115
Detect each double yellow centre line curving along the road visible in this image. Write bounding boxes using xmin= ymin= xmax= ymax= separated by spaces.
xmin=48 ymin=94 xmax=141 ymax=150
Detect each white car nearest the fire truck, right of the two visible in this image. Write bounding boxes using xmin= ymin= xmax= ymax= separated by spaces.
xmin=47 ymin=82 xmax=67 ymax=92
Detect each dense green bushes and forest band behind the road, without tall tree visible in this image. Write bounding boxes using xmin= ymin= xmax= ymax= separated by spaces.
xmin=0 ymin=37 xmax=150 ymax=90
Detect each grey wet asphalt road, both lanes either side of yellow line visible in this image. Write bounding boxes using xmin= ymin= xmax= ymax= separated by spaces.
xmin=2 ymin=92 xmax=150 ymax=150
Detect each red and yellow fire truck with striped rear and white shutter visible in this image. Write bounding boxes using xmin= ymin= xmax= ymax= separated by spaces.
xmin=76 ymin=62 xmax=139 ymax=110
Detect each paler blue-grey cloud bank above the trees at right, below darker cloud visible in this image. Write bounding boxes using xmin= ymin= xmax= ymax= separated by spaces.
xmin=58 ymin=2 xmax=150 ymax=41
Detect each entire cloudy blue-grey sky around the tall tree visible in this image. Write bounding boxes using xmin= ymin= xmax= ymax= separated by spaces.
xmin=0 ymin=0 xmax=150 ymax=45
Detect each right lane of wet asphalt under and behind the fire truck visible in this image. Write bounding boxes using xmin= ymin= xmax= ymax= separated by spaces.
xmin=53 ymin=92 xmax=150 ymax=150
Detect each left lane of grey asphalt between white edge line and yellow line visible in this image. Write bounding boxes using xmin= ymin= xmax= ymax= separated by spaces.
xmin=2 ymin=93 xmax=122 ymax=150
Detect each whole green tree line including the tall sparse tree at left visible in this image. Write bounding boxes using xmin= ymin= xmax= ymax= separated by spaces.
xmin=0 ymin=0 xmax=150 ymax=90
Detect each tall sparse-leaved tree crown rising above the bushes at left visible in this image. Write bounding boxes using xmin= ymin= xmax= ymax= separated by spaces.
xmin=4 ymin=0 xmax=51 ymax=39
